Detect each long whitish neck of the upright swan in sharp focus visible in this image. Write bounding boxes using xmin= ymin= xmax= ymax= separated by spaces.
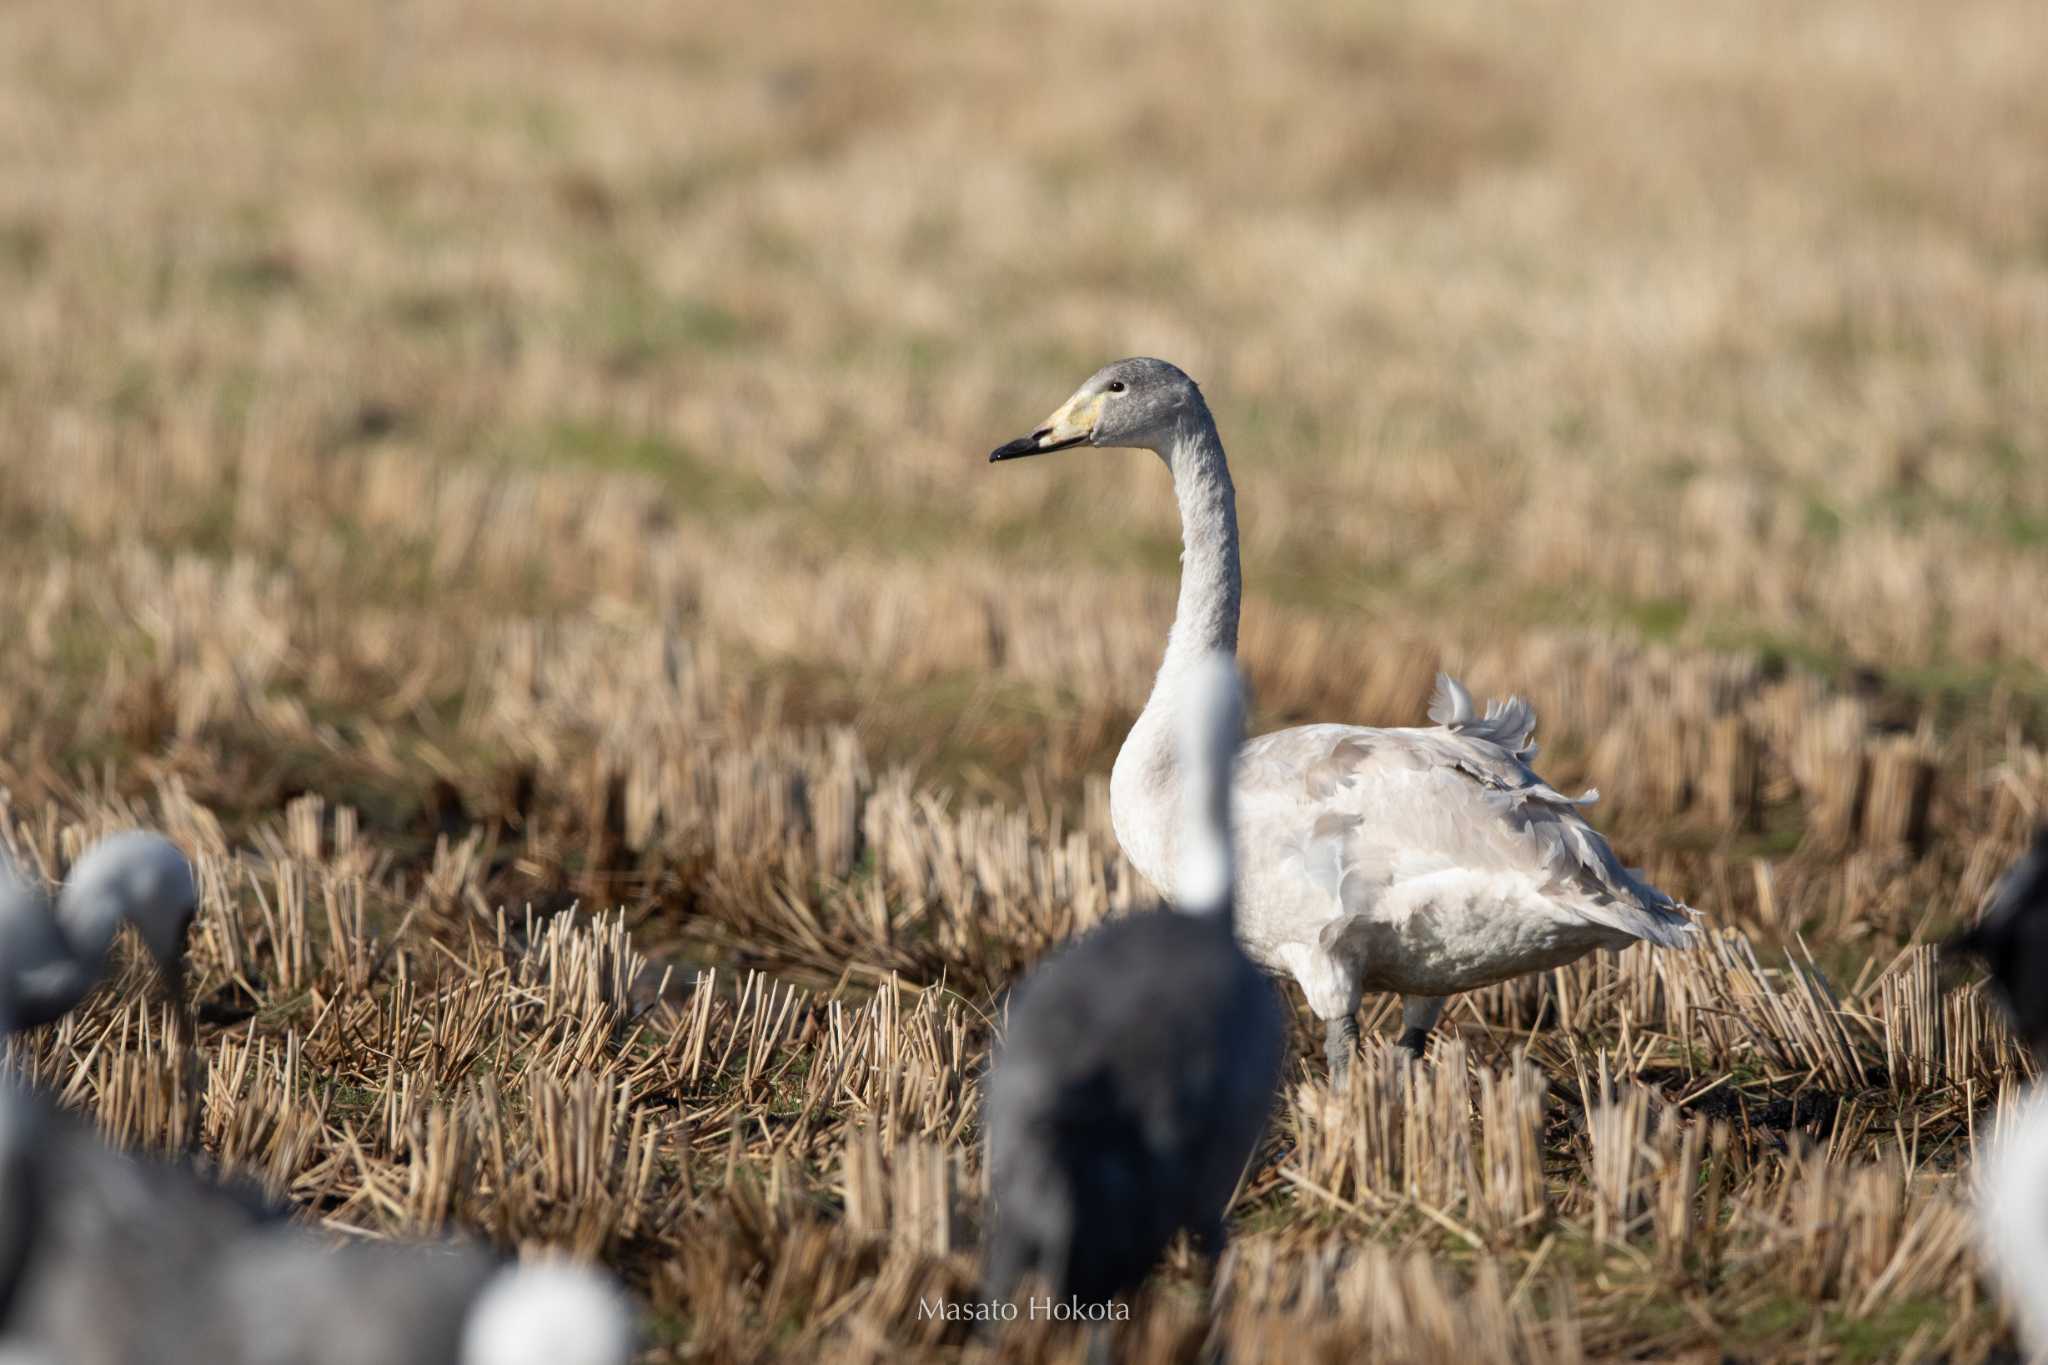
xmin=1110 ymin=417 xmax=1243 ymax=900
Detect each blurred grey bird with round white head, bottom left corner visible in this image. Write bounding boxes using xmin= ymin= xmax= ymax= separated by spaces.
xmin=0 ymin=1083 xmax=635 ymax=1365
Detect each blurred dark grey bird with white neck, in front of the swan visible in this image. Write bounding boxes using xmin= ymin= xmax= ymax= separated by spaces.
xmin=983 ymin=655 xmax=1284 ymax=1347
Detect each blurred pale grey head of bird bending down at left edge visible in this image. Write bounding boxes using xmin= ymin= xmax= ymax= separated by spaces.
xmin=57 ymin=829 xmax=199 ymax=1009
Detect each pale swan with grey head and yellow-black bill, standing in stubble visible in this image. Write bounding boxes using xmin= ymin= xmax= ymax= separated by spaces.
xmin=989 ymin=358 xmax=1694 ymax=1078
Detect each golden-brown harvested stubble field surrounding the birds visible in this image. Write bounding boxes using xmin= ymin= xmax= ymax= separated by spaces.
xmin=0 ymin=0 xmax=2048 ymax=1359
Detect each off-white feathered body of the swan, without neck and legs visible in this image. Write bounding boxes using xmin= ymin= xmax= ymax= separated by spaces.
xmin=1163 ymin=677 xmax=1690 ymax=1017
